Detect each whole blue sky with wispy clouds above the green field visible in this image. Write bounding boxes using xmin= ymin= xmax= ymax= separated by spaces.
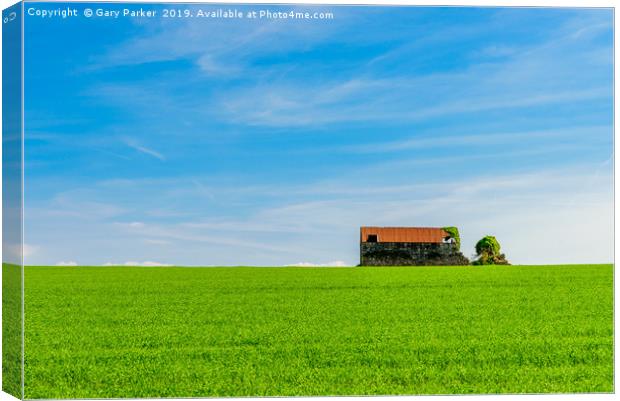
xmin=24 ymin=3 xmax=613 ymax=266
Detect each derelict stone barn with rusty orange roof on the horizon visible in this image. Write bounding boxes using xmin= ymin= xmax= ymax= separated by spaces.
xmin=360 ymin=227 xmax=469 ymax=266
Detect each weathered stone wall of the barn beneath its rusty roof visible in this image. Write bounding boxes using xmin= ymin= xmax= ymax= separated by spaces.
xmin=360 ymin=242 xmax=469 ymax=266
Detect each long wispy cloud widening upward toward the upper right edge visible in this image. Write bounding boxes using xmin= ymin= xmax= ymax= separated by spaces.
xmin=207 ymin=13 xmax=612 ymax=127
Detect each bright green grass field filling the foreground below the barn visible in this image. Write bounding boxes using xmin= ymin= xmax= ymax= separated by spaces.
xmin=25 ymin=265 xmax=613 ymax=398
